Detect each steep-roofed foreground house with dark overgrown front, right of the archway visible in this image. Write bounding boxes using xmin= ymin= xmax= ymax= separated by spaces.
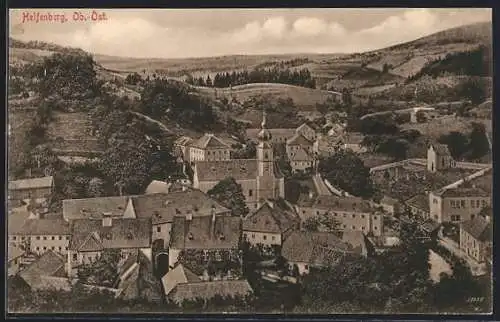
xmin=168 ymin=213 xmax=241 ymax=276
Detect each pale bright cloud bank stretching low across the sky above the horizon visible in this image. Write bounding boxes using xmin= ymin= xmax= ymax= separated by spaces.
xmin=8 ymin=9 xmax=492 ymax=58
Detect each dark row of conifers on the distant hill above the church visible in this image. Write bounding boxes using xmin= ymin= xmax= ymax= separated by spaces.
xmin=186 ymin=66 xmax=316 ymax=88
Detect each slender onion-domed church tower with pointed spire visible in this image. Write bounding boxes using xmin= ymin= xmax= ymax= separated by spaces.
xmin=257 ymin=112 xmax=275 ymax=201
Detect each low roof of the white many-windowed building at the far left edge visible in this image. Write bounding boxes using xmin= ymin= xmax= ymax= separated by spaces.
xmin=9 ymin=218 xmax=70 ymax=235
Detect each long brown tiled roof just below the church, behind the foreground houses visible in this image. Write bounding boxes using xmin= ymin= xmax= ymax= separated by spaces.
xmin=132 ymin=189 xmax=229 ymax=224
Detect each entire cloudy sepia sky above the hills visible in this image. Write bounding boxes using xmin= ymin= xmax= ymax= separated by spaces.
xmin=9 ymin=8 xmax=492 ymax=58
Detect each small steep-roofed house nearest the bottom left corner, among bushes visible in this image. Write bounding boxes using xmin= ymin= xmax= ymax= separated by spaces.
xmin=19 ymin=251 xmax=71 ymax=291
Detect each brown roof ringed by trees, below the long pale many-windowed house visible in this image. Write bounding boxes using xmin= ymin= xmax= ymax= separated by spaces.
xmin=281 ymin=231 xmax=364 ymax=265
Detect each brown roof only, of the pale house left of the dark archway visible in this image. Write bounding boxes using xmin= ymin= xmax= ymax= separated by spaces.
xmin=69 ymin=218 xmax=152 ymax=251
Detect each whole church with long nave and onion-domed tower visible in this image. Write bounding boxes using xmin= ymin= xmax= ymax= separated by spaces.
xmin=193 ymin=112 xmax=285 ymax=210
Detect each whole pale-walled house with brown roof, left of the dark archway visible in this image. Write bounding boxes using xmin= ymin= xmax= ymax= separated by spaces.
xmin=67 ymin=215 xmax=152 ymax=276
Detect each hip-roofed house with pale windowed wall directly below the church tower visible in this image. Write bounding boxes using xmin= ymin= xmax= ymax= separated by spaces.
xmin=243 ymin=201 xmax=300 ymax=246
